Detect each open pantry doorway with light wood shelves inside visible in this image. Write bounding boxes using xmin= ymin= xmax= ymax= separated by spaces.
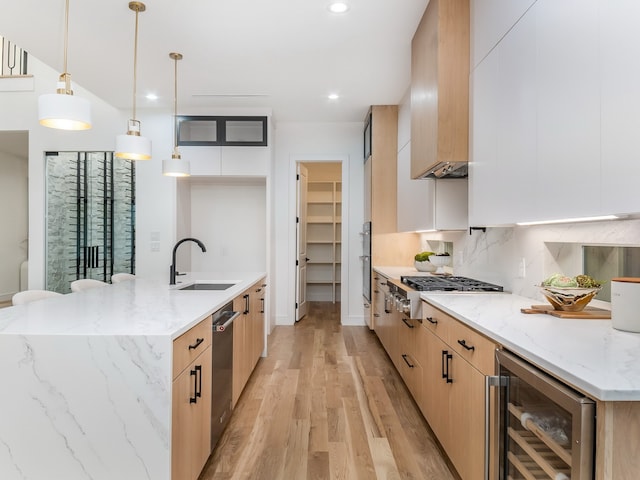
xmin=295 ymin=161 xmax=343 ymax=321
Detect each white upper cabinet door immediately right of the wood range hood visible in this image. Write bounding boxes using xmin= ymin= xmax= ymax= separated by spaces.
xmin=469 ymin=9 xmax=538 ymax=226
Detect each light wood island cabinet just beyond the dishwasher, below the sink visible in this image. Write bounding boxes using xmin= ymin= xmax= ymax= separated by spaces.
xmin=231 ymin=279 xmax=267 ymax=407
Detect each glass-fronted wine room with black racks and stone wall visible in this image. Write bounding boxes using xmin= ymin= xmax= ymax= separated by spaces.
xmin=46 ymin=152 xmax=135 ymax=293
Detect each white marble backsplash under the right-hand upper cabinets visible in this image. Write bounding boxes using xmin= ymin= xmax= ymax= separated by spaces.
xmin=421 ymin=219 xmax=640 ymax=300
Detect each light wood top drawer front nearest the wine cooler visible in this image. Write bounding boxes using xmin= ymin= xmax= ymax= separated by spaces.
xmin=449 ymin=319 xmax=497 ymax=375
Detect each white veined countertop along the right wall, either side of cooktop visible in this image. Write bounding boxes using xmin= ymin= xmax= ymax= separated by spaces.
xmin=374 ymin=267 xmax=640 ymax=401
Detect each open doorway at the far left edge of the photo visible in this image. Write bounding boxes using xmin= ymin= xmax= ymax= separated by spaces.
xmin=0 ymin=130 xmax=29 ymax=306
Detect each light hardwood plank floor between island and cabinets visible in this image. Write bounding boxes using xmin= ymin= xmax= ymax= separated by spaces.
xmin=200 ymin=302 xmax=456 ymax=480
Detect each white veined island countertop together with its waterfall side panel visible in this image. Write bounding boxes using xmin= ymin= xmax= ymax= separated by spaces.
xmin=0 ymin=272 xmax=265 ymax=480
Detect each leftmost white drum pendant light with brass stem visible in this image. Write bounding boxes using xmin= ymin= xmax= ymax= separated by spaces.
xmin=38 ymin=0 xmax=91 ymax=130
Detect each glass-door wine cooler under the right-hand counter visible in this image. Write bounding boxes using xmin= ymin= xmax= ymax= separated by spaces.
xmin=496 ymin=351 xmax=595 ymax=480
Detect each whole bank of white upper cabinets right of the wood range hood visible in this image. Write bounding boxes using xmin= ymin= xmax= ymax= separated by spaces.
xmin=470 ymin=0 xmax=640 ymax=226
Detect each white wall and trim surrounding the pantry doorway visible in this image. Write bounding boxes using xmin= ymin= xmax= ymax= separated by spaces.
xmin=271 ymin=123 xmax=365 ymax=325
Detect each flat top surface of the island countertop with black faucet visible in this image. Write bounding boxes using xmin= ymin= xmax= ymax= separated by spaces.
xmin=0 ymin=272 xmax=265 ymax=338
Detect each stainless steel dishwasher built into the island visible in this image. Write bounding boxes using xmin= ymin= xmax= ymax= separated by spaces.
xmin=211 ymin=302 xmax=240 ymax=451
